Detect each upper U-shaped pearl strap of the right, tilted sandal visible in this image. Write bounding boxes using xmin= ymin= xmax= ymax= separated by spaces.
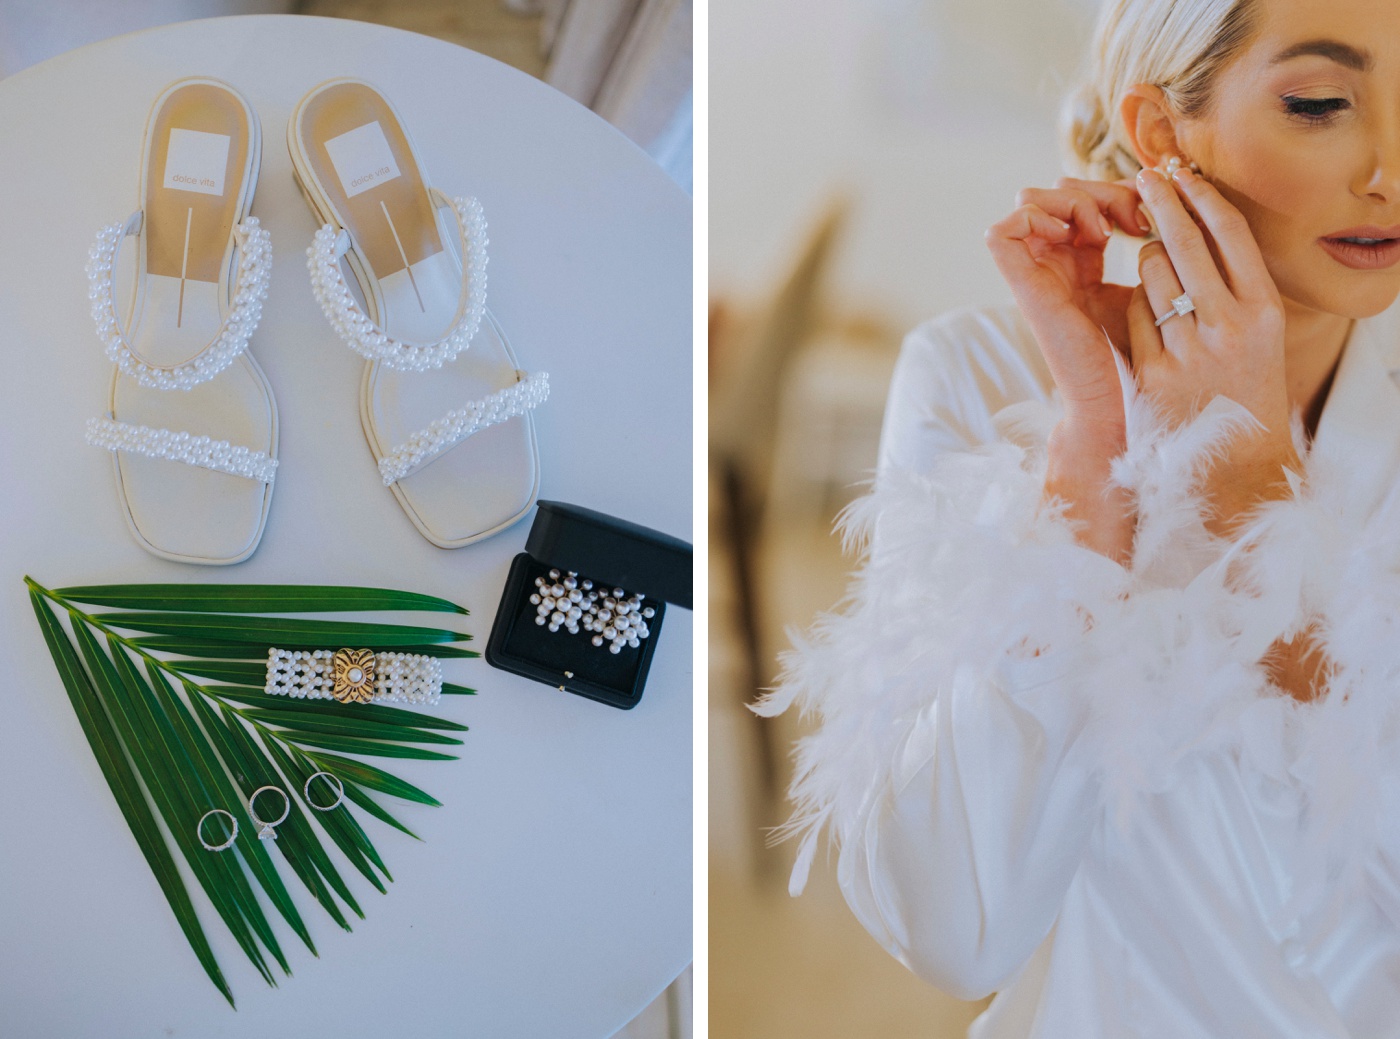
xmin=307 ymin=188 xmax=487 ymax=371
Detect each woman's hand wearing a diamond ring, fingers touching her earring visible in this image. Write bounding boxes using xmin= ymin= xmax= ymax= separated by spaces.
xmin=1128 ymin=168 xmax=1301 ymax=534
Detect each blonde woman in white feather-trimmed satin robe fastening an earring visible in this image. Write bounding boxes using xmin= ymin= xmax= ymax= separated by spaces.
xmin=760 ymin=0 xmax=1400 ymax=1039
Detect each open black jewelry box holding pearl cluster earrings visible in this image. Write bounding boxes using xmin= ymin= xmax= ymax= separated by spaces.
xmin=486 ymin=501 xmax=693 ymax=710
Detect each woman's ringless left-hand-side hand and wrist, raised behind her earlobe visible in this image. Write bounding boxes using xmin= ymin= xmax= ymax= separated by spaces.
xmin=987 ymin=179 xmax=1149 ymax=562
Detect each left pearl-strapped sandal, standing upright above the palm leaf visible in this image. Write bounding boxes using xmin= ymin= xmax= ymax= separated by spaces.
xmin=87 ymin=78 xmax=277 ymax=566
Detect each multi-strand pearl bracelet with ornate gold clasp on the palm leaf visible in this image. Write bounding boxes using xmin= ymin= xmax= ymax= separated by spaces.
xmin=263 ymin=648 xmax=442 ymax=704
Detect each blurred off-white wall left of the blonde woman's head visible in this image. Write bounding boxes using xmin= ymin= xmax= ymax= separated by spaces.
xmin=710 ymin=0 xmax=1096 ymax=325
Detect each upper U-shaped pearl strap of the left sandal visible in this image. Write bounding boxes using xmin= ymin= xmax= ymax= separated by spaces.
xmin=87 ymin=210 xmax=272 ymax=389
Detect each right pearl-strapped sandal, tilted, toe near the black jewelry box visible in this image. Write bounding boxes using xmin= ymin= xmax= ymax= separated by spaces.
xmin=287 ymin=80 xmax=549 ymax=549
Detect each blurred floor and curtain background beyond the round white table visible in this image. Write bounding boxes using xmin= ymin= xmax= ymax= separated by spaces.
xmin=0 ymin=0 xmax=694 ymax=1039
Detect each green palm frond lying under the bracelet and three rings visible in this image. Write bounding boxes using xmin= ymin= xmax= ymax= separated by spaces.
xmin=25 ymin=577 xmax=477 ymax=1004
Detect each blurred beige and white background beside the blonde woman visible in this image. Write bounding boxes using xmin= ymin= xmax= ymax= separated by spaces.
xmin=708 ymin=0 xmax=1114 ymax=1039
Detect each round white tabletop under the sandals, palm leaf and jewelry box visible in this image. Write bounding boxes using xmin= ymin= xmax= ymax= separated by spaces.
xmin=0 ymin=15 xmax=692 ymax=1039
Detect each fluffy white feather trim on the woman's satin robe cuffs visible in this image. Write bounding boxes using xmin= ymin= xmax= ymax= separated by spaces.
xmin=755 ymin=358 xmax=1400 ymax=935
